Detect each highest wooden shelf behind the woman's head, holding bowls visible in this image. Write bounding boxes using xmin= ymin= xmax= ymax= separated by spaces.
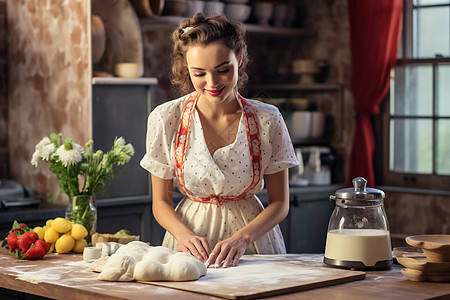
xmin=139 ymin=16 xmax=317 ymax=38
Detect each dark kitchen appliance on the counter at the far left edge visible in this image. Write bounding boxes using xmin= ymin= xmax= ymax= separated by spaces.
xmin=0 ymin=180 xmax=41 ymax=211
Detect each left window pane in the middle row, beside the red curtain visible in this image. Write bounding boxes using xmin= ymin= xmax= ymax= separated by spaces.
xmin=390 ymin=65 xmax=433 ymax=116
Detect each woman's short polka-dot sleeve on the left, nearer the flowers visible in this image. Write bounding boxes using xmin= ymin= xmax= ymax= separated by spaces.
xmin=141 ymin=101 xmax=180 ymax=179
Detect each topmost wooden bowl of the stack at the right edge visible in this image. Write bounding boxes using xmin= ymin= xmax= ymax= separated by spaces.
xmin=405 ymin=234 xmax=450 ymax=262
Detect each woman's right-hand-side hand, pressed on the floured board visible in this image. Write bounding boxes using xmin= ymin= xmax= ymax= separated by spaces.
xmin=205 ymin=234 xmax=249 ymax=268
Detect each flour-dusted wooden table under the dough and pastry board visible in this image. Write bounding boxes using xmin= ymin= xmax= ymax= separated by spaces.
xmin=0 ymin=249 xmax=450 ymax=300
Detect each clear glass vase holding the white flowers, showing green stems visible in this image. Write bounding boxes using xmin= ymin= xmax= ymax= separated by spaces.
xmin=66 ymin=195 xmax=97 ymax=244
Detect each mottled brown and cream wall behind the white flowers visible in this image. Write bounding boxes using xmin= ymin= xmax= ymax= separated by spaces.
xmin=7 ymin=0 xmax=92 ymax=201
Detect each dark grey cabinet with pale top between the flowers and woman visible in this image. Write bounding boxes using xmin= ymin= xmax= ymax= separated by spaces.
xmin=92 ymin=77 xmax=158 ymax=241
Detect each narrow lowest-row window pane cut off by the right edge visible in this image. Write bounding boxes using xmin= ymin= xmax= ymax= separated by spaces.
xmin=436 ymin=120 xmax=450 ymax=175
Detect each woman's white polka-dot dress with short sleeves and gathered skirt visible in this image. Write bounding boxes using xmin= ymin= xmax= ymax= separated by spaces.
xmin=141 ymin=95 xmax=298 ymax=254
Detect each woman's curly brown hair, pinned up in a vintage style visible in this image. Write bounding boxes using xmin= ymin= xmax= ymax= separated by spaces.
xmin=171 ymin=13 xmax=249 ymax=93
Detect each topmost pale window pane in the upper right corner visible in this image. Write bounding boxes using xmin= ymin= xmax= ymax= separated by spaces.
xmin=413 ymin=7 xmax=450 ymax=58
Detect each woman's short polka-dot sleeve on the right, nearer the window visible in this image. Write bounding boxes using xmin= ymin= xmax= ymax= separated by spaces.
xmin=264 ymin=109 xmax=298 ymax=174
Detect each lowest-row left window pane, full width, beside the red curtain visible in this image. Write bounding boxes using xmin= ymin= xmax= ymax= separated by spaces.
xmin=389 ymin=119 xmax=433 ymax=174
